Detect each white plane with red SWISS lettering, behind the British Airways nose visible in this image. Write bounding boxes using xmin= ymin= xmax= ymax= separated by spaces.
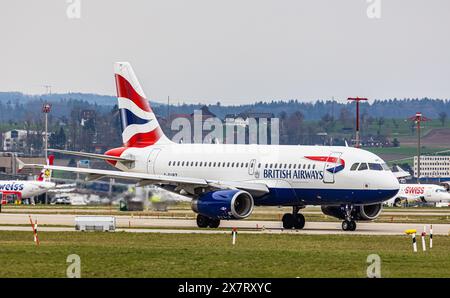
xmin=385 ymin=184 xmax=450 ymax=207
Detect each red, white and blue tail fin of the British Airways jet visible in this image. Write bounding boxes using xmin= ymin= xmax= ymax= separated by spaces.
xmin=114 ymin=62 xmax=170 ymax=147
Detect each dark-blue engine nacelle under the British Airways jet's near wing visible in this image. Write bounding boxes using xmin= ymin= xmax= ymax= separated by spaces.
xmin=191 ymin=189 xmax=254 ymax=219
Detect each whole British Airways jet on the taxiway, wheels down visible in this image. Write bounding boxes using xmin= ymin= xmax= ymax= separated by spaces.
xmin=23 ymin=62 xmax=399 ymax=231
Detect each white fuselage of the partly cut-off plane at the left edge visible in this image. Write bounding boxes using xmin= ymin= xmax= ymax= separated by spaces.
xmin=0 ymin=180 xmax=55 ymax=199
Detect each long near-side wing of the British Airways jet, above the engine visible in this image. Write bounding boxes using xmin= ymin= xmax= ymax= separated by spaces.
xmin=19 ymin=163 xmax=269 ymax=197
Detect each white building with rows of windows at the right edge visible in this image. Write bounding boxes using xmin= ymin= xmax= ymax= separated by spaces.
xmin=414 ymin=155 xmax=450 ymax=180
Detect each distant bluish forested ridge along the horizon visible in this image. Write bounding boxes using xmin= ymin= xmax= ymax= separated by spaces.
xmin=0 ymin=92 xmax=450 ymax=121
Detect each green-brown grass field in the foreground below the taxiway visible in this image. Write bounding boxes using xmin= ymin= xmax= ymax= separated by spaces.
xmin=0 ymin=231 xmax=450 ymax=277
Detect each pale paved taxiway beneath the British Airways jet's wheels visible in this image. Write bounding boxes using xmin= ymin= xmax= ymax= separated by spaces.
xmin=0 ymin=213 xmax=450 ymax=235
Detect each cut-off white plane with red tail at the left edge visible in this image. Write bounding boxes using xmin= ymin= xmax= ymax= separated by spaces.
xmin=0 ymin=155 xmax=56 ymax=202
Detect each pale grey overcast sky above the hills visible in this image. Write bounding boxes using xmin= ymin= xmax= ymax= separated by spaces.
xmin=0 ymin=0 xmax=450 ymax=104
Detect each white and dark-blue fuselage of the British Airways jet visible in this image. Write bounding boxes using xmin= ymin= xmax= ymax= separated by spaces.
xmin=110 ymin=143 xmax=399 ymax=205
